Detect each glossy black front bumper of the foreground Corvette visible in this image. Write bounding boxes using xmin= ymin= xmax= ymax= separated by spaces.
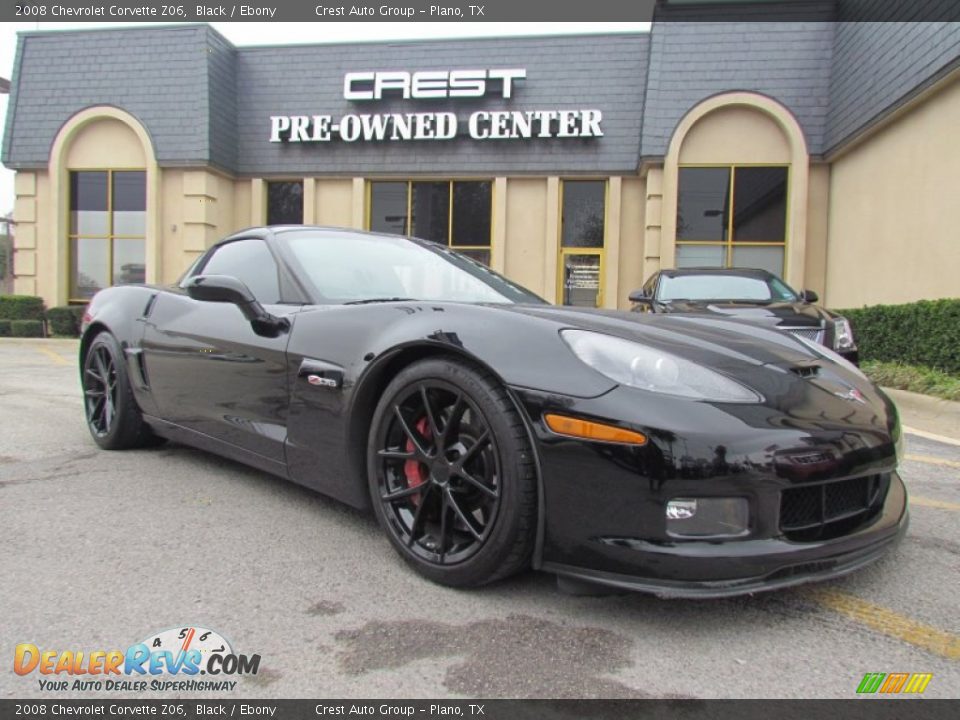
xmin=517 ymin=388 xmax=909 ymax=597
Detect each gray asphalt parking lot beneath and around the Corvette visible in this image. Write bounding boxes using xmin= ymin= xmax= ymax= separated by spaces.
xmin=0 ymin=340 xmax=960 ymax=698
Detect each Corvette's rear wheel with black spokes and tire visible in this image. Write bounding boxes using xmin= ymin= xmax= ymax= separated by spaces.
xmin=81 ymin=331 xmax=154 ymax=450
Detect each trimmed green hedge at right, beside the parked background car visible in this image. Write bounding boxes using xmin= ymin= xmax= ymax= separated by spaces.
xmin=838 ymin=298 xmax=960 ymax=375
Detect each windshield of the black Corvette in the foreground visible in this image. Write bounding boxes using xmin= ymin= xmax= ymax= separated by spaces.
xmin=279 ymin=230 xmax=545 ymax=304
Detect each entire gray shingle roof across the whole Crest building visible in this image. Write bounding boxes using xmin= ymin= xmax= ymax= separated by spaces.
xmin=2 ymin=16 xmax=960 ymax=176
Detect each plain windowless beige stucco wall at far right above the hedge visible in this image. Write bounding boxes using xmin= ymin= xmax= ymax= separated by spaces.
xmin=825 ymin=82 xmax=960 ymax=308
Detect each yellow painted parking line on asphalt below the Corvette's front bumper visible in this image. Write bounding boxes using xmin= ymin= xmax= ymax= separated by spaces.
xmin=809 ymin=588 xmax=960 ymax=660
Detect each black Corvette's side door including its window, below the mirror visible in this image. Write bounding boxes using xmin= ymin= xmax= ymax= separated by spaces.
xmin=143 ymin=238 xmax=300 ymax=463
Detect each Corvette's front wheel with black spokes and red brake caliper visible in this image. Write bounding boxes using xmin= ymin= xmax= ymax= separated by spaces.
xmin=367 ymin=358 xmax=537 ymax=587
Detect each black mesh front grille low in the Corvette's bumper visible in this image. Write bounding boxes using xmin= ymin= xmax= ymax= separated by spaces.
xmin=780 ymin=475 xmax=890 ymax=542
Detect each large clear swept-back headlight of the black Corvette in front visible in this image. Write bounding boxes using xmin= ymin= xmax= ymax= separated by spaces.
xmin=560 ymin=330 xmax=761 ymax=403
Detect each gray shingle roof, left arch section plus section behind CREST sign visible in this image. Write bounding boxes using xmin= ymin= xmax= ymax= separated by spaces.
xmin=3 ymin=25 xmax=649 ymax=175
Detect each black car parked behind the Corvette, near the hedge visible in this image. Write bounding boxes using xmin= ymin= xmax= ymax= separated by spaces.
xmin=630 ymin=268 xmax=858 ymax=365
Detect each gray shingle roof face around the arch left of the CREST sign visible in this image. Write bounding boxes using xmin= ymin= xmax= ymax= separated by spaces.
xmin=3 ymin=25 xmax=219 ymax=168
